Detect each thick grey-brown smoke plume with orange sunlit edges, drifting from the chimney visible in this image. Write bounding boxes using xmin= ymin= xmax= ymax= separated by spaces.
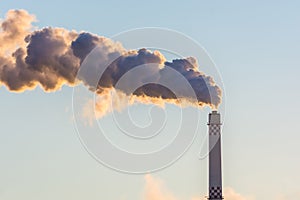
xmin=0 ymin=10 xmax=221 ymax=112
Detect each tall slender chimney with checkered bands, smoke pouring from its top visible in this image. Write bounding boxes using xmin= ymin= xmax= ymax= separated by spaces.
xmin=208 ymin=111 xmax=223 ymax=200
